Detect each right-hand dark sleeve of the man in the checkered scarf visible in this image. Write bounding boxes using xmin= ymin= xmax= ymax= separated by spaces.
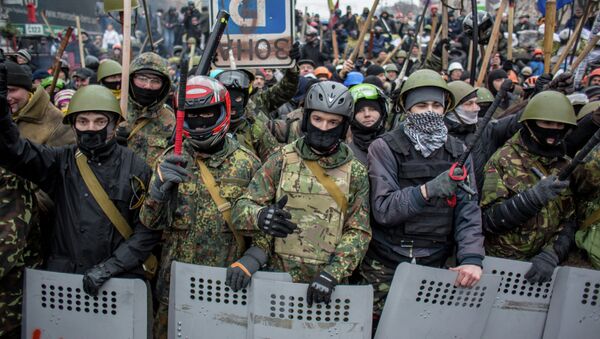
xmin=454 ymin=156 xmax=485 ymax=266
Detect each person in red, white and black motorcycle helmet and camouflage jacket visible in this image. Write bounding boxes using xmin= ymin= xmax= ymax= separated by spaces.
xmin=140 ymin=77 xmax=260 ymax=338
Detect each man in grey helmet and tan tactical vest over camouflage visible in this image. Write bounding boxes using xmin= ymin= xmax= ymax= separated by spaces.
xmin=233 ymin=81 xmax=371 ymax=304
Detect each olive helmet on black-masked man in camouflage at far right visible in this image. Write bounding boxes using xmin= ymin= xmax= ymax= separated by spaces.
xmin=519 ymin=91 xmax=577 ymax=126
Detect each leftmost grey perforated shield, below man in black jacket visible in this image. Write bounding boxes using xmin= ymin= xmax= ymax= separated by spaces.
xmin=22 ymin=269 xmax=152 ymax=339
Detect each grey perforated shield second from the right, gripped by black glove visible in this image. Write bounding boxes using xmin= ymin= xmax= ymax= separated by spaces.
xmin=482 ymin=257 xmax=556 ymax=339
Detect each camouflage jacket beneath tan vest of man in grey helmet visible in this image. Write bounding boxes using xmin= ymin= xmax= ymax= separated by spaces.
xmin=233 ymin=139 xmax=371 ymax=282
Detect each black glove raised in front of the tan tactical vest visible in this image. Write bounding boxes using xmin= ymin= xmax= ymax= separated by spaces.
xmin=258 ymin=195 xmax=298 ymax=238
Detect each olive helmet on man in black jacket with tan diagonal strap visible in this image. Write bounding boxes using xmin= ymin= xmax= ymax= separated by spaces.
xmin=63 ymin=85 xmax=122 ymax=125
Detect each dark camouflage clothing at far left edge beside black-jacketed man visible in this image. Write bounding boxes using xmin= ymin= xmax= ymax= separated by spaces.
xmin=0 ymin=168 xmax=42 ymax=338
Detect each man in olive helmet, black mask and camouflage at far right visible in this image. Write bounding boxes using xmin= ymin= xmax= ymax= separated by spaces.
xmin=481 ymin=91 xmax=576 ymax=283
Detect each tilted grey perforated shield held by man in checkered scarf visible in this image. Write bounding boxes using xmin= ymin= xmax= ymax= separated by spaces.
xmin=375 ymin=263 xmax=500 ymax=339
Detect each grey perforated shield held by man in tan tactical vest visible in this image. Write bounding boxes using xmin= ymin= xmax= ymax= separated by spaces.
xmin=246 ymin=280 xmax=373 ymax=339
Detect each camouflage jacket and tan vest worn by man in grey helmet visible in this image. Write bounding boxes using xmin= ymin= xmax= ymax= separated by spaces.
xmin=233 ymin=139 xmax=371 ymax=283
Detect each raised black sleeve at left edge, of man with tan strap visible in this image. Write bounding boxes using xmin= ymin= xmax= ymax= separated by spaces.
xmin=0 ymin=116 xmax=64 ymax=192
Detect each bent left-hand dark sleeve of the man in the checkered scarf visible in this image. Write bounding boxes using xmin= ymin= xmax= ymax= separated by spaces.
xmin=367 ymin=139 xmax=427 ymax=227
